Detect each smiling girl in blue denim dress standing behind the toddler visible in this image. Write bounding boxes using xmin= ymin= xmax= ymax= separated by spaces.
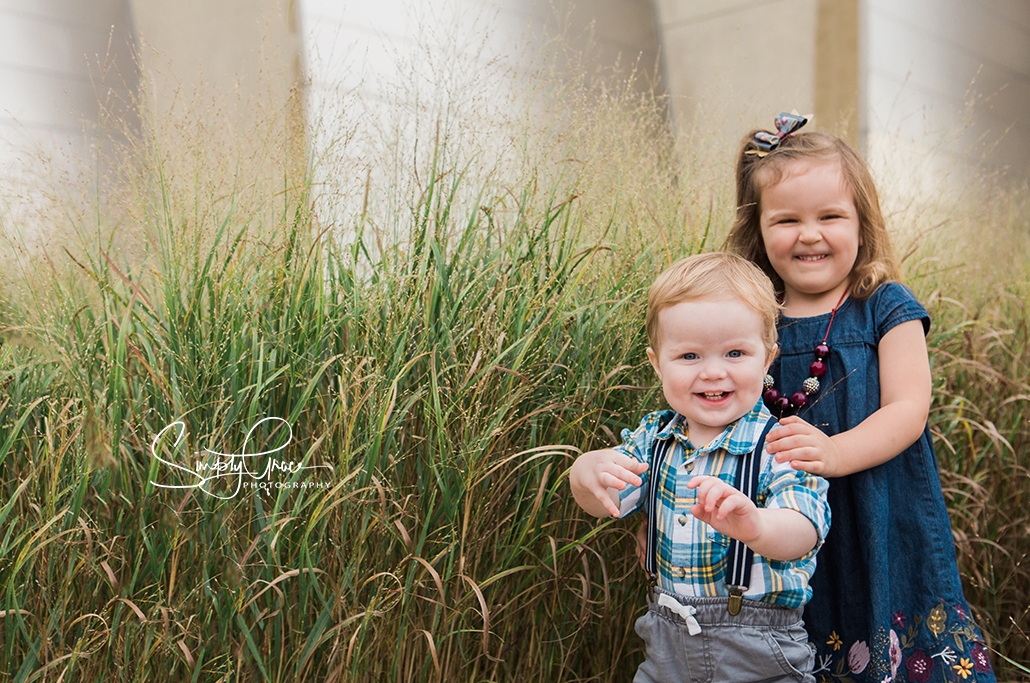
xmin=727 ymin=114 xmax=995 ymax=683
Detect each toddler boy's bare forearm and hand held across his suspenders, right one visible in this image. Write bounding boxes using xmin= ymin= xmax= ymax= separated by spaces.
xmin=687 ymin=476 xmax=819 ymax=561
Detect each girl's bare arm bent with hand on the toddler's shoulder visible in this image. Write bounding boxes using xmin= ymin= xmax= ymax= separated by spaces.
xmin=766 ymin=320 xmax=932 ymax=477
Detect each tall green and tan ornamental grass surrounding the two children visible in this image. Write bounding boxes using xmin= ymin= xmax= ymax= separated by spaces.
xmin=0 ymin=33 xmax=1030 ymax=683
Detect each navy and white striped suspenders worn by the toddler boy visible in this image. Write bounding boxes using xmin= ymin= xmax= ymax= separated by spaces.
xmin=644 ymin=415 xmax=777 ymax=616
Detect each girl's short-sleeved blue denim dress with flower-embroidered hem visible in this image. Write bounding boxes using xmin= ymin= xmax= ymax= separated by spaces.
xmin=769 ymin=282 xmax=995 ymax=683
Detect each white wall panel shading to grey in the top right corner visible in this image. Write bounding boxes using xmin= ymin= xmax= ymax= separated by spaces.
xmin=863 ymin=0 xmax=1030 ymax=177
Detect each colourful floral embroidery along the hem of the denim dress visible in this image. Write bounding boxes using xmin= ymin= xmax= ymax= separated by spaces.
xmin=813 ymin=602 xmax=991 ymax=683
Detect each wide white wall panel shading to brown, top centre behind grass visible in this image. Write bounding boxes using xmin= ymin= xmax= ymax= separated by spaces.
xmin=299 ymin=0 xmax=658 ymax=225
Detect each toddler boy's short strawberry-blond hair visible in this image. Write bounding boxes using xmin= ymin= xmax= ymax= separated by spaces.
xmin=644 ymin=251 xmax=780 ymax=361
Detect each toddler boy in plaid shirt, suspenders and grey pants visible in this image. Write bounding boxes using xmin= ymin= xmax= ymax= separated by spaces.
xmin=570 ymin=253 xmax=830 ymax=683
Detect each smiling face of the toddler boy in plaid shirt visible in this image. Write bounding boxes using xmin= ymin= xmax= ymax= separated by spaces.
xmin=647 ymin=301 xmax=771 ymax=447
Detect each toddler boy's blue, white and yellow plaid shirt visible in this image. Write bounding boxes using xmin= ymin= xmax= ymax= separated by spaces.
xmin=616 ymin=399 xmax=830 ymax=608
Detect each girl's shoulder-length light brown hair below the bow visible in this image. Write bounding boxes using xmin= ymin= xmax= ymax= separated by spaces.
xmin=724 ymin=131 xmax=901 ymax=299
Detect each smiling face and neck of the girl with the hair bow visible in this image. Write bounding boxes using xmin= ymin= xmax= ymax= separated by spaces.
xmin=759 ymin=160 xmax=862 ymax=317
